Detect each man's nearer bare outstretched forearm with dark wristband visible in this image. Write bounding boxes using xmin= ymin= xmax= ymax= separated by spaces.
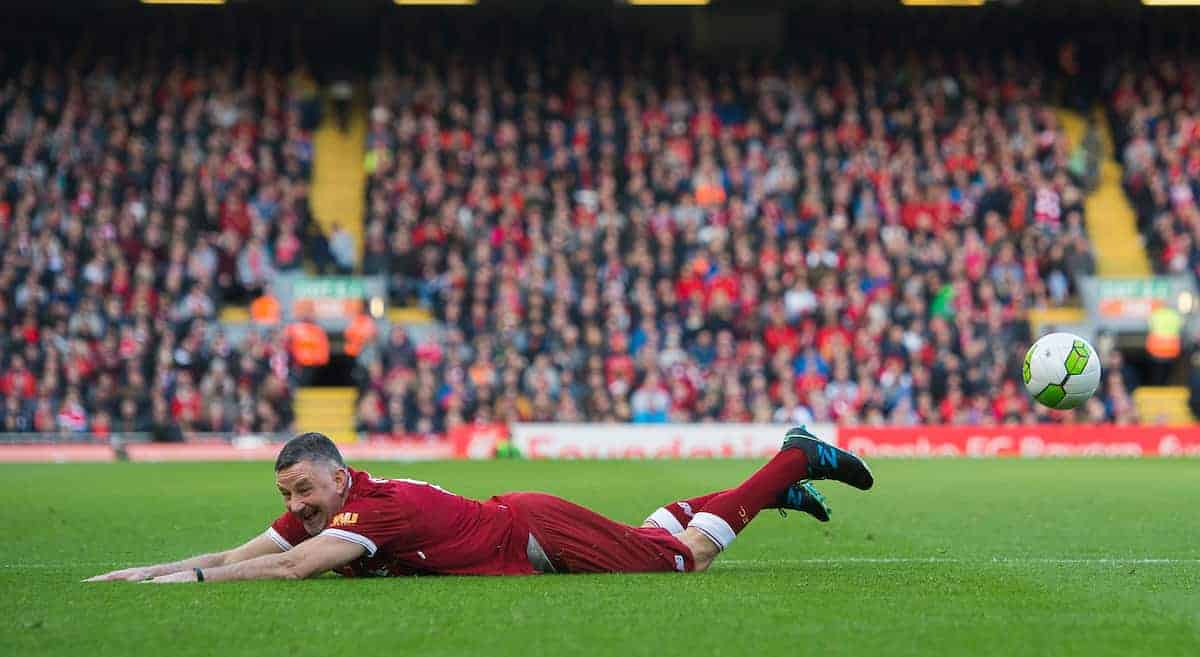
xmin=150 ymin=536 xmax=366 ymax=584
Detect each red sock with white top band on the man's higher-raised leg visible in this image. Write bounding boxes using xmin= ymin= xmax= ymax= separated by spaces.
xmin=688 ymin=450 xmax=809 ymax=550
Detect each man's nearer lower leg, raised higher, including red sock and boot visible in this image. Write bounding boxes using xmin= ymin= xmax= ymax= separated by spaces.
xmin=678 ymin=427 xmax=875 ymax=571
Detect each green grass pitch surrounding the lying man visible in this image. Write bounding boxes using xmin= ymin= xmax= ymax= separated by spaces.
xmin=0 ymin=460 xmax=1200 ymax=657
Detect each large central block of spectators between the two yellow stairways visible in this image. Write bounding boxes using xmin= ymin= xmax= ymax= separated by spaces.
xmin=359 ymin=39 xmax=1135 ymax=433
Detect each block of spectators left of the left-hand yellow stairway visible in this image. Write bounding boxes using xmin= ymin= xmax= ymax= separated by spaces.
xmin=0 ymin=50 xmax=318 ymax=440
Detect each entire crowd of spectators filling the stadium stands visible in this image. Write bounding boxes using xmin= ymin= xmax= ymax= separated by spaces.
xmin=0 ymin=30 xmax=1161 ymax=439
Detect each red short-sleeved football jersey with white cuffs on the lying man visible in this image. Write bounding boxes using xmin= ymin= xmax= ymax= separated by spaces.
xmin=266 ymin=469 xmax=535 ymax=577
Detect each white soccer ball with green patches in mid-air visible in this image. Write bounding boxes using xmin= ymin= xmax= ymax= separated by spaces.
xmin=1021 ymin=333 xmax=1100 ymax=410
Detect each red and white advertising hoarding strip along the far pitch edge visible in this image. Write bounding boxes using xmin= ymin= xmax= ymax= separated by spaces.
xmin=0 ymin=423 xmax=1200 ymax=463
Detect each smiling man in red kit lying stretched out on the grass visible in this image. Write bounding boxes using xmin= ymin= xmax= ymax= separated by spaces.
xmin=85 ymin=427 xmax=874 ymax=583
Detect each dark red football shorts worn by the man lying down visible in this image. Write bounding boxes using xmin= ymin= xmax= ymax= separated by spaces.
xmin=497 ymin=493 xmax=695 ymax=573
